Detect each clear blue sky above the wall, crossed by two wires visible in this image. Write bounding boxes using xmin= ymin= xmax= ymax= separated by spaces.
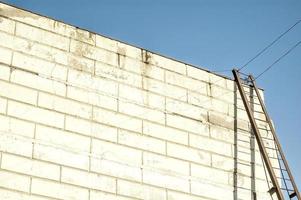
xmin=6 ymin=0 xmax=301 ymax=189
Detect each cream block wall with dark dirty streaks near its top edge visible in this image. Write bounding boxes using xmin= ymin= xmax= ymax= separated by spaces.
xmin=0 ymin=4 xmax=276 ymax=200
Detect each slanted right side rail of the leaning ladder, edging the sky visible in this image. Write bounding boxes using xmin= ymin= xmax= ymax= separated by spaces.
xmin=249 ymin=75 xmax=301 ymax=200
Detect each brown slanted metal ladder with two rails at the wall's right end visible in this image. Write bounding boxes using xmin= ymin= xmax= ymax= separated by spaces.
xmin=232 ymin=69 xmax=301 ymax=200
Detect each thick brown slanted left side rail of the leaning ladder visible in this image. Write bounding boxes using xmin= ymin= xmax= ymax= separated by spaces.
xmin=232 ymin=69 xmax=284 ymax=200
